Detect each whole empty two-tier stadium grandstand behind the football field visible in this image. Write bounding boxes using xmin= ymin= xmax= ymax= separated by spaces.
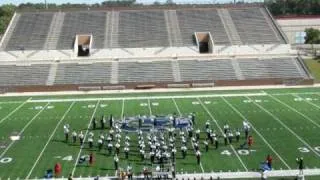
xmin=0 ymin=3 xmax=313 ymax=91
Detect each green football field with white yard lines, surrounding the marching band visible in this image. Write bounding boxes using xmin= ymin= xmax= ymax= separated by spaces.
xmin=0 ymin=88 xmax=320 ymax=179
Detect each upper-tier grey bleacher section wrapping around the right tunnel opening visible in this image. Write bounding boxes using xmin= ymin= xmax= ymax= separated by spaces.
xmin=177 ymin=9 xmax=230 ymax=46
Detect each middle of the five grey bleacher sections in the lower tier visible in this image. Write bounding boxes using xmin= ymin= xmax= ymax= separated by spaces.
xmin=119 ymin=61 xmax=173 ymax=82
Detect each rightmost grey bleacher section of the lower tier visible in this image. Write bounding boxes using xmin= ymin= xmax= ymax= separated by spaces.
xmin=238 ymin=58 xmax=307 ymax=79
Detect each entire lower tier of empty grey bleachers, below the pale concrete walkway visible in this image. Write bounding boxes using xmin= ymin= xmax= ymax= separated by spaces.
xmin=0 ymin=58 xmax=309 ymax=86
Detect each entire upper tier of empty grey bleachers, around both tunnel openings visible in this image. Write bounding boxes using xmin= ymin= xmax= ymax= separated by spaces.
xmin=2 ymin=7 xmax=284 ymax=51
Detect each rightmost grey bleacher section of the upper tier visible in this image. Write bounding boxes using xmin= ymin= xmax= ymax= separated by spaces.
xmin=229 ymin=8 xmax=282 ymax=44
